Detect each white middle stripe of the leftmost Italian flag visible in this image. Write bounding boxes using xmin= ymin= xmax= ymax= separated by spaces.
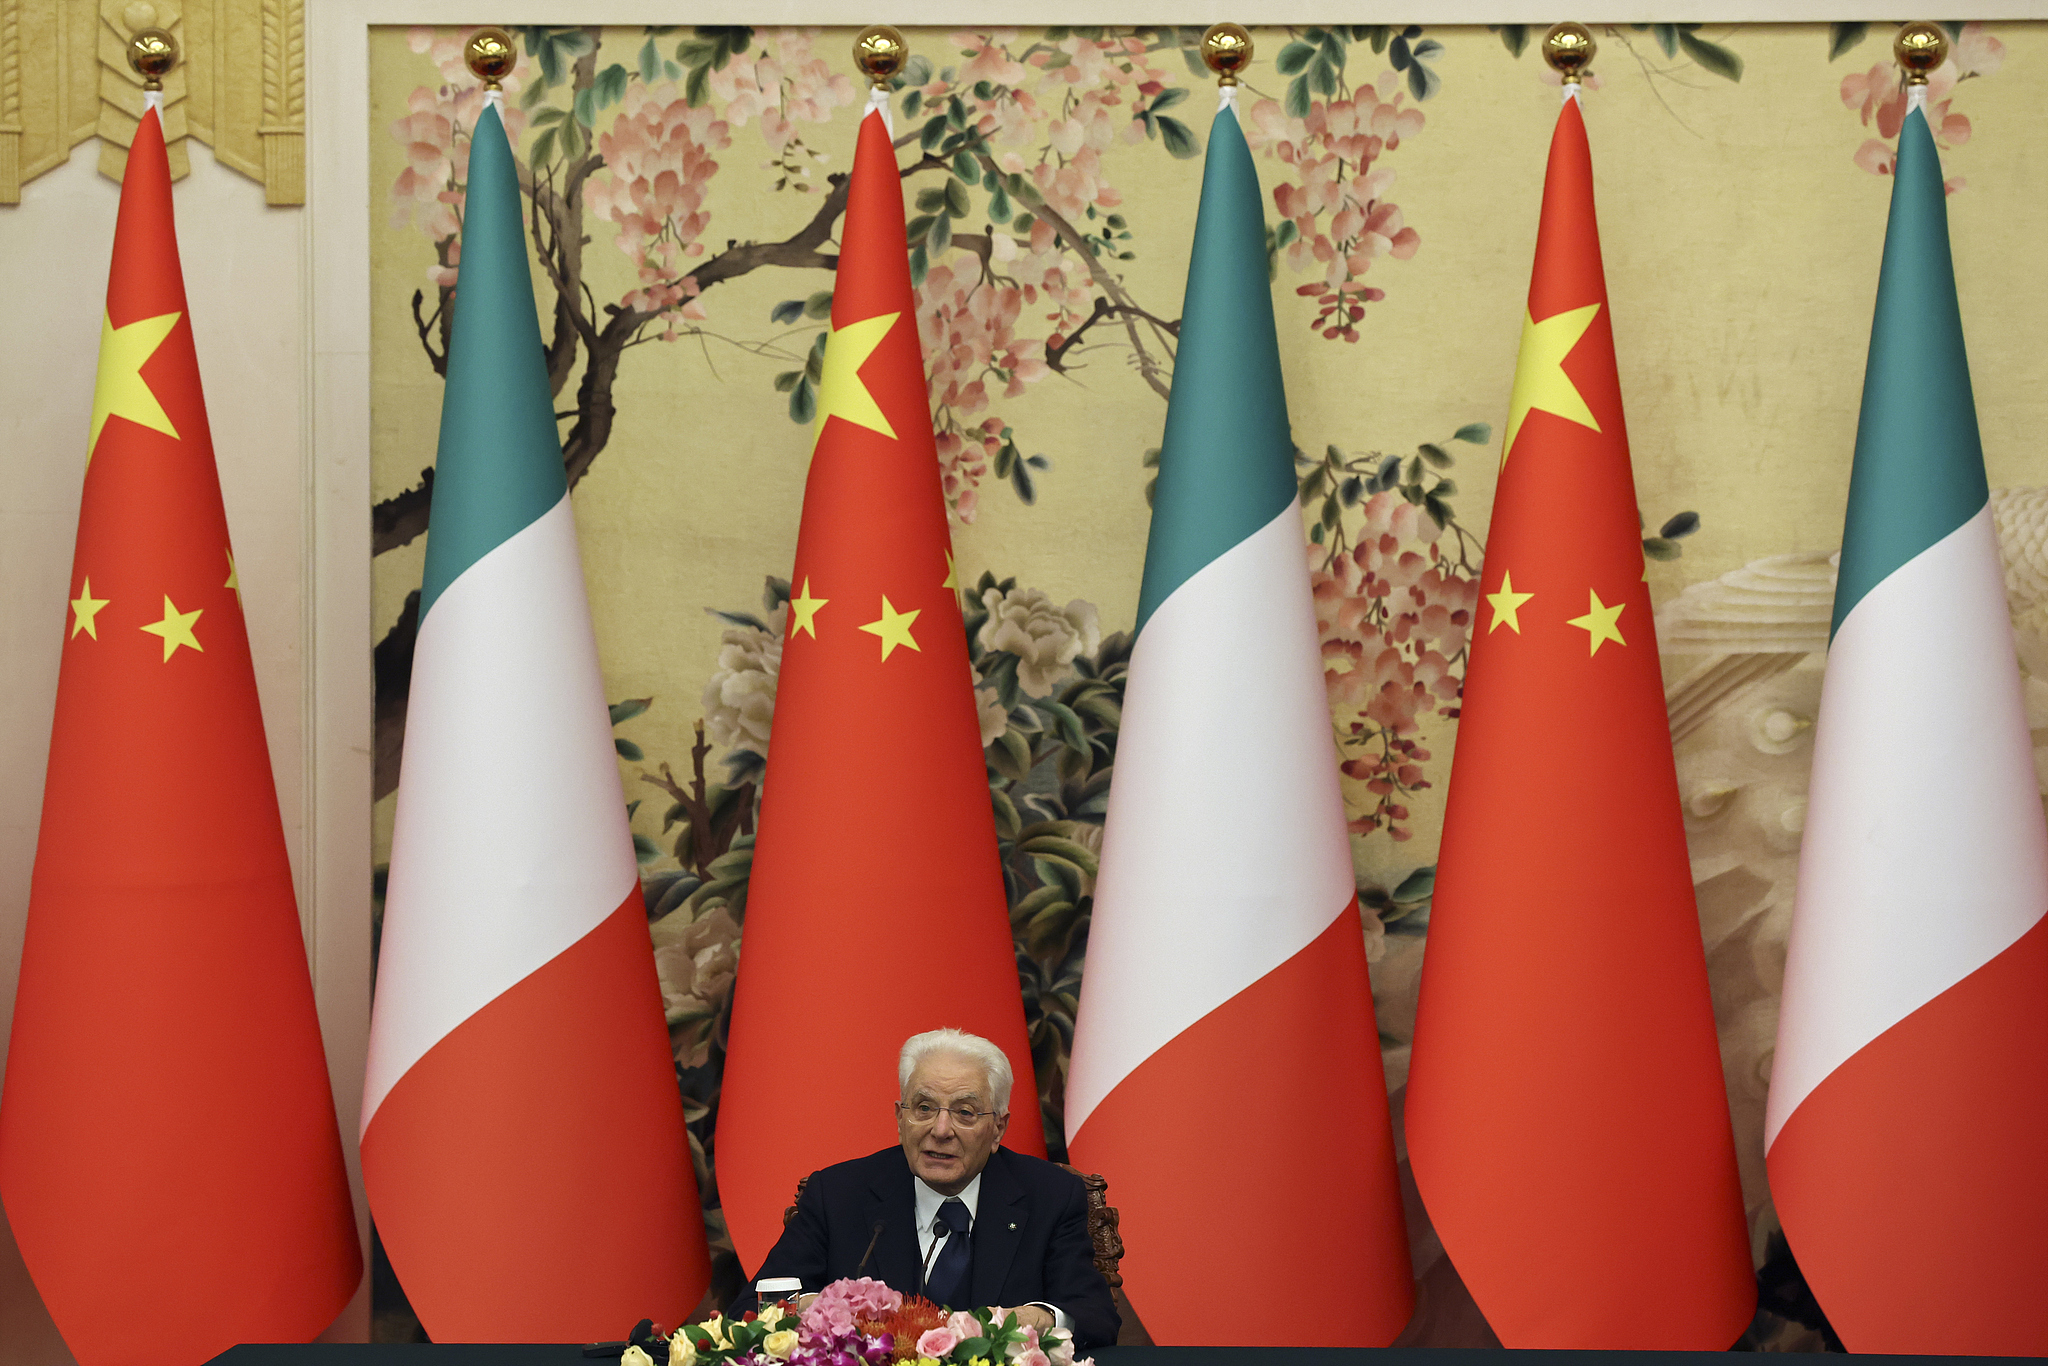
xmin=362 ymin=494 xmax=639 ymax=1128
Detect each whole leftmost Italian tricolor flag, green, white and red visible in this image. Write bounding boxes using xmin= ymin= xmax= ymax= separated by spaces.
xmin=362 ymin=104 xmax=709 ymax=1341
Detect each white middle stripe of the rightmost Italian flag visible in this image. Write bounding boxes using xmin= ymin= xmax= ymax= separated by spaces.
xmin=1763 ymin=506 xmax=2048 ymax=1147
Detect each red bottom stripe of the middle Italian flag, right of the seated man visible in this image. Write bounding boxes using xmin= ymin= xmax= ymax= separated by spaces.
xmin=1071 ymin=901 xmax=1415 ymax=1348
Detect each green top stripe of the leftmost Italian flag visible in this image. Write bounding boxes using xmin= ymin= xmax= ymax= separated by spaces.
xmin=420 ymin=106 xmax=569 ymax=621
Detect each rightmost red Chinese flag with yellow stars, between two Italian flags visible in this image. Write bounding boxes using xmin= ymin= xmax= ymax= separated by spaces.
xmin=1405 ymin=98 xmax=1755 ymax=1350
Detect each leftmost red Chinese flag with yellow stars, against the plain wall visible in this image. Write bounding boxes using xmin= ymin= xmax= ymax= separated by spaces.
xmin=0 ymin=111 xmax=362 ymax=1366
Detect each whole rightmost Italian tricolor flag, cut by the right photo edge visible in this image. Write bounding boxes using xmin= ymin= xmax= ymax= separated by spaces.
xmin=1765 ymin=101 xmax=2048 ymax=1356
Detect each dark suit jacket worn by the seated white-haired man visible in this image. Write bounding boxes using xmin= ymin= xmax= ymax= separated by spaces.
xmin=741 ymin=1147 xmax=1118 ymax=1350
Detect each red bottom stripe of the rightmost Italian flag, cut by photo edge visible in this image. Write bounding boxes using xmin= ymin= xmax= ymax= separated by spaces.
xmin=1769 ymin=920 xmax=2048 ymax=1356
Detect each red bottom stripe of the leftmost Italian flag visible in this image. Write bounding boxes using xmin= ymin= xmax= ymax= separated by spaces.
xmin=362 ymin=887 xmax=711 ymax=1341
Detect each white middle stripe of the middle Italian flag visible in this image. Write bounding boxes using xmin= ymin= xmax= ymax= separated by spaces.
xmin=1067 ymin=500 xmax=1356 ymax=1139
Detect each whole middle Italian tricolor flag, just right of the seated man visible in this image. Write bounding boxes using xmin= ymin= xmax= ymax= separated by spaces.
xmin=1067 ymin=90 xmax=1413 ymax=1348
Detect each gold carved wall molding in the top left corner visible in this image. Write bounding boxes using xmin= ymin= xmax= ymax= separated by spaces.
xmin=0 ymin=0 xmax=305 ymax=205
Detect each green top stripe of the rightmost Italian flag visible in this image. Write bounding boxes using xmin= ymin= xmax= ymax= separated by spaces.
xmin=1829 ymin=109 xmax=1991 ymax=637
